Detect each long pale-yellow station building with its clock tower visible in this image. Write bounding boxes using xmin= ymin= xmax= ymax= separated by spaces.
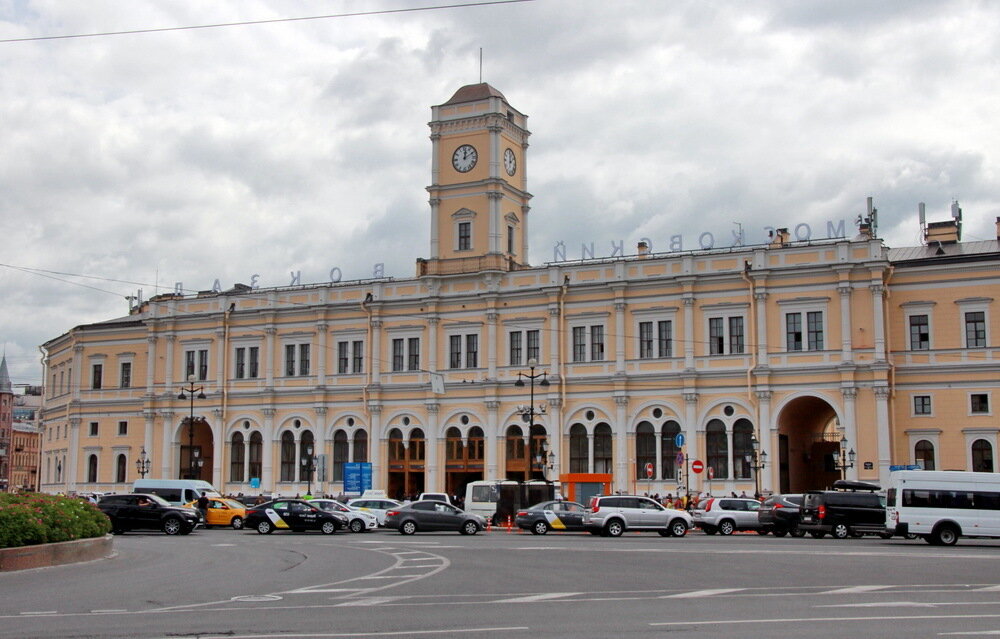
xmin=40 ymin=84 xmax=1000 ymax=497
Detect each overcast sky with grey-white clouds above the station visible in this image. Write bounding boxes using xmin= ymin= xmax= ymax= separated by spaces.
xmin=0 ymin=0 xmax=1000 ymax=384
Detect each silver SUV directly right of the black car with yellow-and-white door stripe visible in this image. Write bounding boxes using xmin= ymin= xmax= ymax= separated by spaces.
xmin=583 ymin=495 xmax=694 ymax=537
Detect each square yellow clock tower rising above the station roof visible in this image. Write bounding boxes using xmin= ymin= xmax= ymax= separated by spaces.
xmin=417 ymin=83 xmax=531 ymax=275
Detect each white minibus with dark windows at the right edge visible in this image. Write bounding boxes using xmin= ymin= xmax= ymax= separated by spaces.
xmin=885 ymin=470 xmax=1000 ymax=546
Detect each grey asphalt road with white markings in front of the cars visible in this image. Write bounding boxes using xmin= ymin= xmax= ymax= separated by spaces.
xmin=0 ymin=529 xmax=1000 ymax=639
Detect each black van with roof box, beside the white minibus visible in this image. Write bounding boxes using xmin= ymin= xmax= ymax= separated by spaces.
xmin=799 ymin=480 xmax=892 ymax=539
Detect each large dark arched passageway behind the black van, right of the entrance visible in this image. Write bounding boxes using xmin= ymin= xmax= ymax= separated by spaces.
xmin=777 ymin=397 xmax=840 ymax=493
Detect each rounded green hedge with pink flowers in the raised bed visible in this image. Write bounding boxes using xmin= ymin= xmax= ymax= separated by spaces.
xmin=0 ymin=493 xmax=111 ymax=548
